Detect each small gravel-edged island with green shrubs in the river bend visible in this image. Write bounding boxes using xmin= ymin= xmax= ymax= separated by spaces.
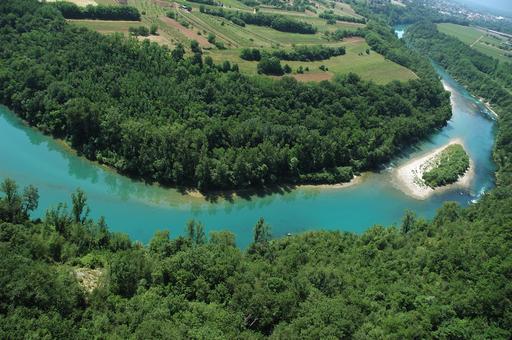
xmin=395 ymin=139 xmax=473 ymax=199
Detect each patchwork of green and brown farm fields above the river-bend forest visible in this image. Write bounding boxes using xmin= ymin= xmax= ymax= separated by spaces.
xmin=66 ymin=0 xmax=416 ymax=84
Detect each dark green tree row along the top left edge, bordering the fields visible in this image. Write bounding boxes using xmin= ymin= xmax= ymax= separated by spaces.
xmin=51 ymin=1 xmax=140 ymax=21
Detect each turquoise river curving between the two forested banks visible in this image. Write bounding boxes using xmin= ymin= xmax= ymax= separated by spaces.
xmin=0 ymin=69 xmax=495 ymax=247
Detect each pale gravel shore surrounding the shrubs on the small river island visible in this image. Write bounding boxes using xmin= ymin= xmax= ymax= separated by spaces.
xmin=393 ymin=139 xmax=475 ymax=200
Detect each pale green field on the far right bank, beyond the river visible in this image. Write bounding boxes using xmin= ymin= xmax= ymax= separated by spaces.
xmin=437 ymin=23 xmax=512 ymax=62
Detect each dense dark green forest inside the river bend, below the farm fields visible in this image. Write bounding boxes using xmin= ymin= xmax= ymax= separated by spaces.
xmin=0 ymin=0 xmax=450 ymax=189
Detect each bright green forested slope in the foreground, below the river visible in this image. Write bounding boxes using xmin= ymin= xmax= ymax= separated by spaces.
xmin=0 ymin=167 xmax=512 ymax=339
